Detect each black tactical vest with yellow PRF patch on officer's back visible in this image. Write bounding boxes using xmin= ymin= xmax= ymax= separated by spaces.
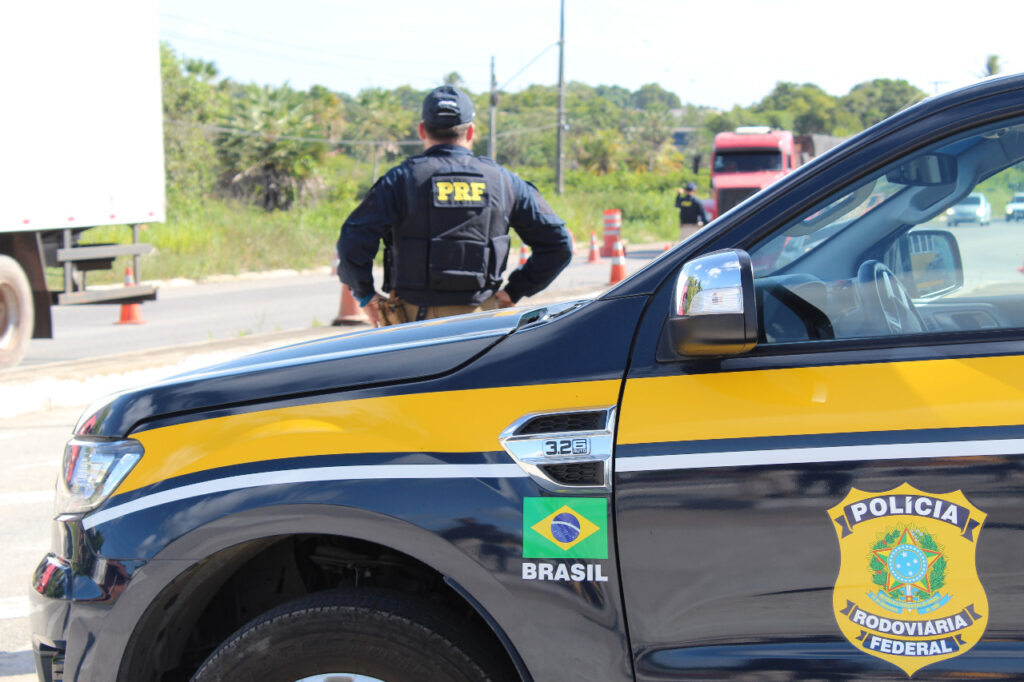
xmin=390 ymin=155 xmax=514 ymax=305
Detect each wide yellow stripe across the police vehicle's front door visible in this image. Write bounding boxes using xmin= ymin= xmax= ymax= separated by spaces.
xmin=617 ymin=356 xmax=1024 ymax=444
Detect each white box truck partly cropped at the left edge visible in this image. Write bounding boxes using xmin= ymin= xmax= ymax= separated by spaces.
xmin=0 ymin=0 xmax=166 ymax=368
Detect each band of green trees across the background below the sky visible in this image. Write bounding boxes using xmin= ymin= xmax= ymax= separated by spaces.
xmin=161 ymin=43 xmax=925 ymax=211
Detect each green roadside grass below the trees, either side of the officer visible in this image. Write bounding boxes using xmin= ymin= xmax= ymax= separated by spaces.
xmin=70 ymin=159 xmax=689 ymax=288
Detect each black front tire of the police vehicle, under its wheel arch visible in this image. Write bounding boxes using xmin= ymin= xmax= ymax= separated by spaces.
xmin=193 ymin=589 xmax=509 ymax=682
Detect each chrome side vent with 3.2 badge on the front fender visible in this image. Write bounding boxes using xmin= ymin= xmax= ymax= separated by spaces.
xmin=499 ymin=408 xmax=615 ymax=493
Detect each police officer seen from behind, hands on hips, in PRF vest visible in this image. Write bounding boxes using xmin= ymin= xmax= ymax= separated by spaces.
xmin=338 ymin=85 xmax=572 ymax=325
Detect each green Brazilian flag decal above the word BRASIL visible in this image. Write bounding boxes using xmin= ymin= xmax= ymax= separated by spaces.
xmin=522 ymin=498 xmax=608 ymax=559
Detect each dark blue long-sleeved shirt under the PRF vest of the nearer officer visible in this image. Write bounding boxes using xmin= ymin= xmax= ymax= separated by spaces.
xmin=337 ymin=144 xmax=572 ymax=304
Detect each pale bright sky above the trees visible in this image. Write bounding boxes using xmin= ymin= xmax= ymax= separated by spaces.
xmin=160 ymin=0 xmax=1024 ymax=109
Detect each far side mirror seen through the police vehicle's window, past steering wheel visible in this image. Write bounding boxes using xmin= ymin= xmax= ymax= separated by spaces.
xmin=886 ymin=229 xmax=964 ymax=299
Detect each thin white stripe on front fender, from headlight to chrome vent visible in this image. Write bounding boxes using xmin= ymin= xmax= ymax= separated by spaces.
xmin=82 ymin=464 xmax=526 ymax=528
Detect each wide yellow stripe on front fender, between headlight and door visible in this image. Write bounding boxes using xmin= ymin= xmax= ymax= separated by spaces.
xmin=118 ymin=380 xmax=620 ymax=493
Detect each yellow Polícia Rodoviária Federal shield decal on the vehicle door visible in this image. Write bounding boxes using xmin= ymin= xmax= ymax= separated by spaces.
xmin=828 ymin=483 xmax=988 ymax=677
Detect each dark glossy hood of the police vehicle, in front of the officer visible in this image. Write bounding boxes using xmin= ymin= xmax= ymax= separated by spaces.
xmin=75 ymin=308 xmax=543 ymax=437
